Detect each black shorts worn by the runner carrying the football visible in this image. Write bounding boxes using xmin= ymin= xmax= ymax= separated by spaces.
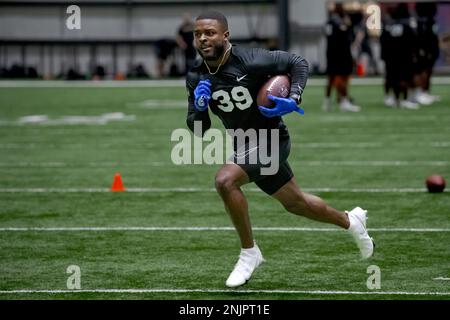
xmin=229 ymin=135 xmax=294 ymax=195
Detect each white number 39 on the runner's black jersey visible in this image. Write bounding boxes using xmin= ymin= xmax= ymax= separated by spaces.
xmin=211 ymin=86 xmax=253 ymax=112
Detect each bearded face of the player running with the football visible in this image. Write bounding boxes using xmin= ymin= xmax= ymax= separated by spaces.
xmin=194 ymin=19 xmax=229 ymax=61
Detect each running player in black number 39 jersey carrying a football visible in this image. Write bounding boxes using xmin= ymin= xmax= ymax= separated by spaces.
xmin=186 ymin=12 xmax=373 ymax=287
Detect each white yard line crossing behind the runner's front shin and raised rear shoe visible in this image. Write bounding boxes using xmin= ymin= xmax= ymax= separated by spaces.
xmin=0 ymin=226 xmax=450 ymax=232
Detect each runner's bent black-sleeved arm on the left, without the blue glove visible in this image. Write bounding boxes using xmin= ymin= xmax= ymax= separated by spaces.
xmin=186 ymin=73 xmax=211 ymax=136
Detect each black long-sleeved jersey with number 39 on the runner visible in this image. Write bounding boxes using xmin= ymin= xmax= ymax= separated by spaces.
xmin=186 ymin=46 xmax=308 ymax=133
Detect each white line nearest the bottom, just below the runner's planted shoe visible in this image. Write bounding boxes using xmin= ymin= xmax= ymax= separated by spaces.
xmin=0 ymin=289 xmax=450 ymax=296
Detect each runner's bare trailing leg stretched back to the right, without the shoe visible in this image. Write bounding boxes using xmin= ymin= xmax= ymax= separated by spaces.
xmin=272 ymin=177 xmax=350 ymax=229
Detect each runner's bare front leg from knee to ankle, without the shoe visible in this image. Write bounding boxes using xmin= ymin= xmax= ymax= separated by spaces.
xmin=215 ymin=163 xmax=253 ymax=248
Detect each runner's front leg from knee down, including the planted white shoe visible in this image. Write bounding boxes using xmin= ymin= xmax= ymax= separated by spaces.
xmin=216 ymin=163 xmax=264 ymax=287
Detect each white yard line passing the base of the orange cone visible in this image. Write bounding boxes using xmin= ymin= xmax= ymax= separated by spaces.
xmin=0 ymin=187 xmax=442 ymax=193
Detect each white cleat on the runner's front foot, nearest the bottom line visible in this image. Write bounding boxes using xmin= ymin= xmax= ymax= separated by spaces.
xmin=225 ymin=243 xmax=264 ymax=288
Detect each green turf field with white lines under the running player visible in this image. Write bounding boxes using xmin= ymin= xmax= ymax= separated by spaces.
xmin=0 ymin=80 xmax=450 ymax=299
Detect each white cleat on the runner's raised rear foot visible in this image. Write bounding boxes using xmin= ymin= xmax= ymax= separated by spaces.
xmin=346 ymin=207 xmax=375 ymax=259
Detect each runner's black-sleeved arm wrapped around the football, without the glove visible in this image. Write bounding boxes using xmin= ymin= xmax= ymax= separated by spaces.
xmin=250 ymin=49 xmax=309 ymax=104
